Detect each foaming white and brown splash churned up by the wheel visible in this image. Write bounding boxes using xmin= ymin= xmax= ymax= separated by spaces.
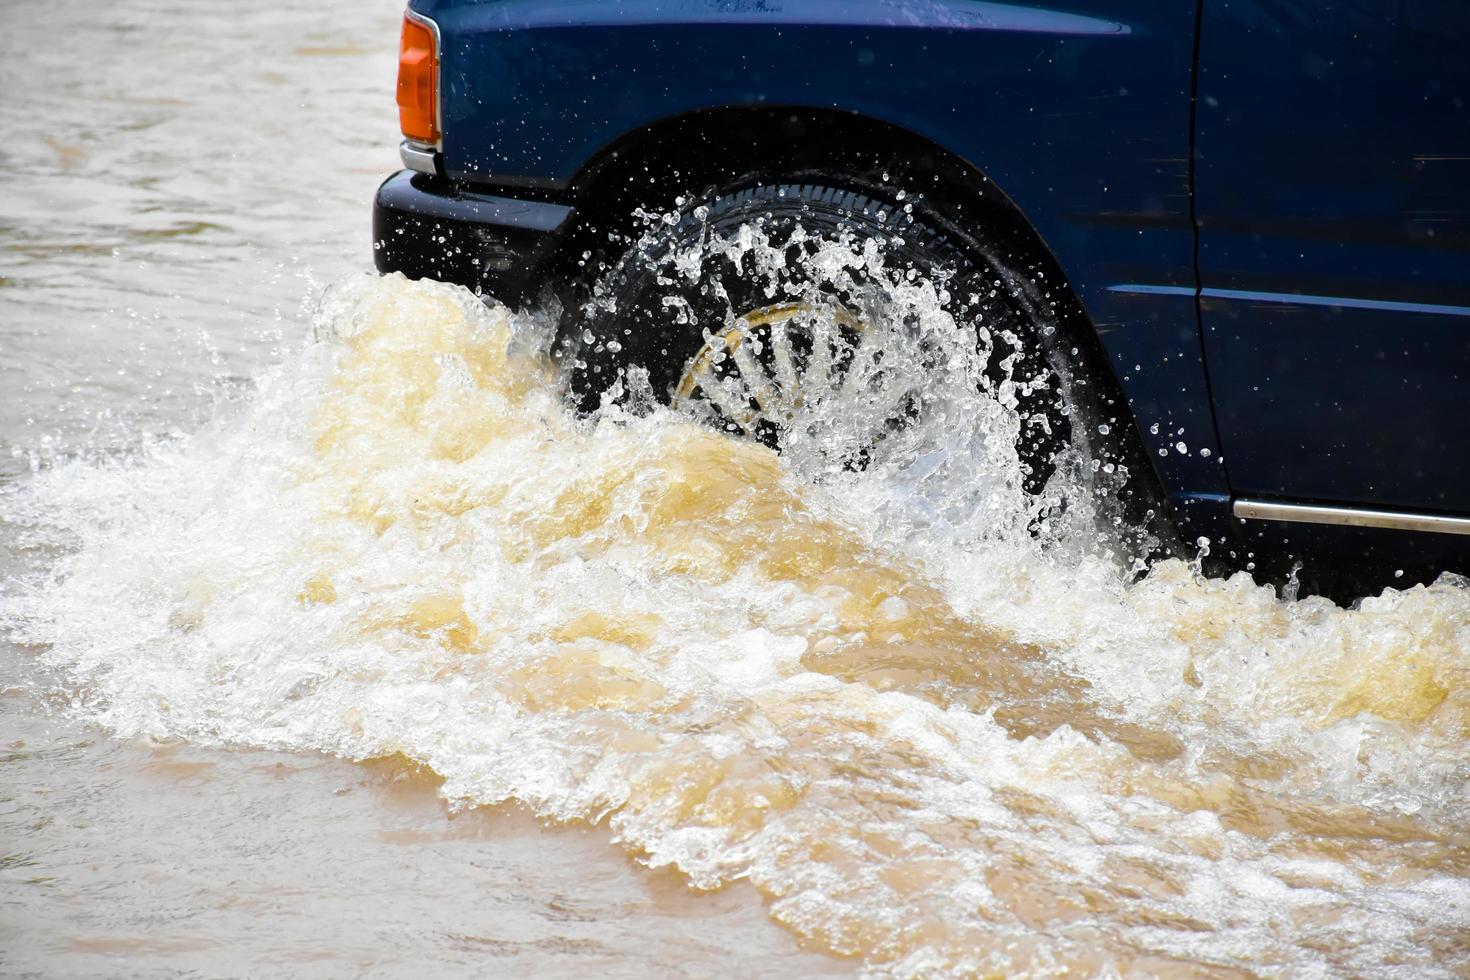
xmin=0 ymin=276 xmax=1470 ymax=976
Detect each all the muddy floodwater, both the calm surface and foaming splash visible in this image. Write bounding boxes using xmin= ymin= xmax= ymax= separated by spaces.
xmin=0 ymin=1 xmax=1470 ymax=977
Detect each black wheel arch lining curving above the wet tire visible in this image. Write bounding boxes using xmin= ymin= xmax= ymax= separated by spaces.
xmin=547 ymin=106 xmax=1163 ymax=543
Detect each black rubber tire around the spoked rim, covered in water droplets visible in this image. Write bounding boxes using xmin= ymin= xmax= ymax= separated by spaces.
xmin=563 ymin=181 xmax=1161 ymax=554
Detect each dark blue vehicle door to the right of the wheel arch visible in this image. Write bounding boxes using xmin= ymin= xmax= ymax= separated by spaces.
xmin=1195 ymin=0 xmax=1470 ymax=514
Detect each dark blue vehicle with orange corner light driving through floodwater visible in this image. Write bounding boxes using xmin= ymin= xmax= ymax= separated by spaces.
xmin=375 ymin=0 xmax=1470 ymax=585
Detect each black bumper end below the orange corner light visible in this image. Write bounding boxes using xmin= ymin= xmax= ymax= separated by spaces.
xmin=372 ymin=170 xmax=572 ymax=304
